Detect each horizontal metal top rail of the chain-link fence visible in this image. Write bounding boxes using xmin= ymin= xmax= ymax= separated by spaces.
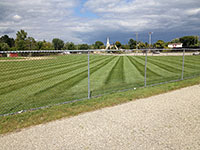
xmin=0 ymin=48 xmax=200 ymax=54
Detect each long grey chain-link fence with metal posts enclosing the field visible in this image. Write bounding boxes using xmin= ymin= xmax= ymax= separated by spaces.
xmin=0 ymin=49 xmax=200 ymax=116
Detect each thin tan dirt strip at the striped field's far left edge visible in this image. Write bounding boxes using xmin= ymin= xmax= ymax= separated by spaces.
xmin=0 ymin=57 xmax=55 ymax=62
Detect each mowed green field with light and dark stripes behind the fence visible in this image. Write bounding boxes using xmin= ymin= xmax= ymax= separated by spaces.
xmin=0 ymin=55 xmax=200 ymax=114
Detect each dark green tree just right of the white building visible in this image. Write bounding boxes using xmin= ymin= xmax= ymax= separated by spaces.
xmin=180 ymin=36 xmax=199 ymax=47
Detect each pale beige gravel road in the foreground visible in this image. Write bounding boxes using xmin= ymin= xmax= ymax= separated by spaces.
xmin=0 ymin=85 xmax=200 ymax=150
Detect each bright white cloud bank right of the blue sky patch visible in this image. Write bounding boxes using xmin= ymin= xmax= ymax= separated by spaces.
xmin=85 ymin=0 xmax=200 ymax=31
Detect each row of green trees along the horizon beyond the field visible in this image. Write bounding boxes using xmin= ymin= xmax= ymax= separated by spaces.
xmin=0 ymin=30 xmax=200 ymax=51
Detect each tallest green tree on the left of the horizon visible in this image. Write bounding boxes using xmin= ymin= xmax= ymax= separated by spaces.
xmin=15 ymin=30 xmax=27 ymax=50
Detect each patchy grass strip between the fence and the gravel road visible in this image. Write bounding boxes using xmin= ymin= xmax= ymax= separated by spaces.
xmin=0 ymin=77 xmax=200 ymax=134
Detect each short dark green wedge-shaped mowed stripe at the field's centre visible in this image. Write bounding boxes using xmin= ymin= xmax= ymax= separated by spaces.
xmin=105 ymin=56 xmax=125 ymax=85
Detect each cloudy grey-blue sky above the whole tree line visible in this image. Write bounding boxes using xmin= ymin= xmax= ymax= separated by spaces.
xmin=0 ymin=0 xmax=200 ymax=44
